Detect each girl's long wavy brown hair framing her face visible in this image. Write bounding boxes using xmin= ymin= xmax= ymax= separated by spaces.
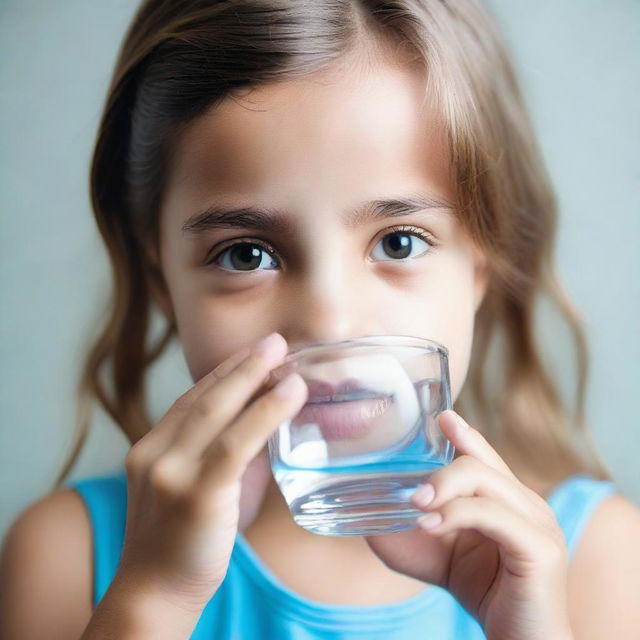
xmin=50 ymin=0 xmax=611 ymax=496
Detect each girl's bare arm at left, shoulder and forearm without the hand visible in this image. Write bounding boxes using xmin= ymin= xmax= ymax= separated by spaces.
xmin=0 ymin=489 xmax=206 ymax=640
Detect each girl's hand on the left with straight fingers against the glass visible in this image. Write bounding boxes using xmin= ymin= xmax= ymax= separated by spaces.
xmin=116 ymin=334 xmax=307 ymax=612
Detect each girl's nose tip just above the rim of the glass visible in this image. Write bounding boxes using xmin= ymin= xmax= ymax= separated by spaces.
xmin=280 ymin=272 xmax=384 ymax=351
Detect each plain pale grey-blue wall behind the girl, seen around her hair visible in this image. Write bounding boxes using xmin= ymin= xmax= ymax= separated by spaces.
xmin=0 ymin=0 xmax=640 ymax=536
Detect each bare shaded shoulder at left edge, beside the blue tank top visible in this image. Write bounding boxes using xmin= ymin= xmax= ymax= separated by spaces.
xmin=0 ymin=488 xmax=92 ymax=640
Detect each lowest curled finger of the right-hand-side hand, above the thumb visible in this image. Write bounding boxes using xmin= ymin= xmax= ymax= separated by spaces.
xmin=416 ymin=497 xmax=566 ymax=576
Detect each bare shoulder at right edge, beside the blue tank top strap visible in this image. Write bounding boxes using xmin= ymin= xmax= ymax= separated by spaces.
xmin=569 ymin=495 xmax=640 ymax=640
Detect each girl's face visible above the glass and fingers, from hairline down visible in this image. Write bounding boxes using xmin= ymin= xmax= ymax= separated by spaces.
xmin=161 ymin=56 xmax=486 ymax=398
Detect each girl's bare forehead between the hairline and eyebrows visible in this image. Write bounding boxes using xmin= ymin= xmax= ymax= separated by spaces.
xmin=165 ymin=64 xmax=453 ymax=224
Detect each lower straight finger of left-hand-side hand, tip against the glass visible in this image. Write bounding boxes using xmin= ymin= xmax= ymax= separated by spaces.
xmin=201 ymin=373 xmax=308 ymax=483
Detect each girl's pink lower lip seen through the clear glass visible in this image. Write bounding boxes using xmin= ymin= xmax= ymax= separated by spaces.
xmin=295 ymin=396 xmax=393 ymax=440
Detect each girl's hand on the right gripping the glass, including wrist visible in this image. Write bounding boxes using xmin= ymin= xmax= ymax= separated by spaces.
xmin=366 ymin=410 xmax=571 ymax=640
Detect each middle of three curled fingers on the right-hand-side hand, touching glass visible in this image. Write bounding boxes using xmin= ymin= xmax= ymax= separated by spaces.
xmin=411 ymin=454 xmax=548 ymax=523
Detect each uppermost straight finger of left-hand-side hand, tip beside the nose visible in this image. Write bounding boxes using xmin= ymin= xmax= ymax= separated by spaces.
xmin=171 ymin=334 xmax=287 ymax=460
